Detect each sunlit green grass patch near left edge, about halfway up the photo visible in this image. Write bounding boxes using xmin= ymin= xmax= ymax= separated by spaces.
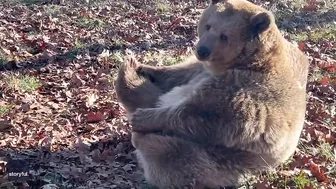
xmin=6 ymin=74 xmax=41 ymax=92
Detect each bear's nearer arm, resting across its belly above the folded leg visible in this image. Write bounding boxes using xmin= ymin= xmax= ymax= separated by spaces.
xmin=130 ymin=79 xmax=227 ymax=143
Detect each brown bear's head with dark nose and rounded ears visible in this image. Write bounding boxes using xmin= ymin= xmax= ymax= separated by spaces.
xmin=195 ymin=0 xmax=281 ymax=74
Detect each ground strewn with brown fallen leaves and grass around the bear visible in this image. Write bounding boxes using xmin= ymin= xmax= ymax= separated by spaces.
xmin=0 ymin=0 xmax=336 ymax=188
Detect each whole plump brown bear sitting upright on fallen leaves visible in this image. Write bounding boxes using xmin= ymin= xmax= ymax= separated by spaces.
xmin=117 ymin=0 xmax=308 ymax=188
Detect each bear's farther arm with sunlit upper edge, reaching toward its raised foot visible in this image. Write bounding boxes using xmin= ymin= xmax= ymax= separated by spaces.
xmin=139 ymin=57 xmax=206 ymax=93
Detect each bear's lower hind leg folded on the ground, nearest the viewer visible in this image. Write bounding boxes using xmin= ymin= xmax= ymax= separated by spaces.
xmin=132 ymin=132 xmax=235 ymax=188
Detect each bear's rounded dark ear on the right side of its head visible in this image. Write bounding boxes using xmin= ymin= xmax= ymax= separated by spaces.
xmin=250 ymin=12 xmax=272 ymax=37
